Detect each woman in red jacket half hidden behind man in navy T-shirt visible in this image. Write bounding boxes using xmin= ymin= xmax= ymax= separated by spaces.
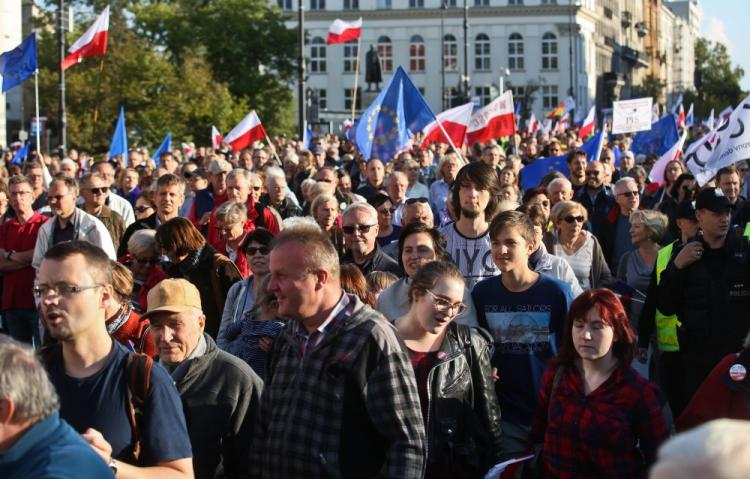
xmin=106 ymin=261 xmax=156 ymax=357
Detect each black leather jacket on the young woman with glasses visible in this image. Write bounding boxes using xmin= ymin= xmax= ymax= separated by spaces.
xmin=425 ymin=322 xmax=501 ymax=477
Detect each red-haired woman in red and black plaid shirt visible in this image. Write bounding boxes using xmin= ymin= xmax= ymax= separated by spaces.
xmin=532 ymin=289 xmax=669 ymax=479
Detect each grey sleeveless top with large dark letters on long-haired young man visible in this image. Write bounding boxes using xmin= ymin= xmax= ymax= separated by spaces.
xmin=440 ymin=223 xmax=499 ymax=290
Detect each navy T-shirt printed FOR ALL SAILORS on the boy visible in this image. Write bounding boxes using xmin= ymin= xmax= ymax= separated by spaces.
xmin=471 ymin=274 xmax=573 ymax=425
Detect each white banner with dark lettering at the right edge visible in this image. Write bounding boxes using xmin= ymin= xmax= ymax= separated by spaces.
xmin=685 ymin=97 xmax=750 ymax=186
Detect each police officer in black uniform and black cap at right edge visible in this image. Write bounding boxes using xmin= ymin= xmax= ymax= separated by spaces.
xmin=656 ymin=188 xmax=750 ymax=406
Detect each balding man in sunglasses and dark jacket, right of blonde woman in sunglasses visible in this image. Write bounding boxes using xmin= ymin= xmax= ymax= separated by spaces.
xmin=594 ymin=176 xmax=641 ymax=271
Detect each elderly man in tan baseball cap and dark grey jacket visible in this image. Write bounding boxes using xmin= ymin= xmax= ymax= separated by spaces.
xmin=143 ymin=279 xmax=263 ymax=479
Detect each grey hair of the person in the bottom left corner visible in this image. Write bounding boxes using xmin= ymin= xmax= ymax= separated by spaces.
xmin=0 ymin=335 xmax=60 ymax=424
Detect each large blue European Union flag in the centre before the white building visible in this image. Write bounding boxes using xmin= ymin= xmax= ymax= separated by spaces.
xmin=351 ymin=67 xmax=436 ymax=163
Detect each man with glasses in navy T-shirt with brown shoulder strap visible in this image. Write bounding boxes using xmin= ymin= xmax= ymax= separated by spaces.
xmin=34 ymin=241 xmax=193 ymax=478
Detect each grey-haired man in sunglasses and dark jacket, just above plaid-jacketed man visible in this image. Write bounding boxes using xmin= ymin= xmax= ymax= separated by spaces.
xmin=342 ymin=202 xmax=402 ymax=276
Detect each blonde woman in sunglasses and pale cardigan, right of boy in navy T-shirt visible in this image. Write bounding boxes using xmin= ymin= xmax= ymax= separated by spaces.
xmin=544 ymin=201 xmax=612 ymax=290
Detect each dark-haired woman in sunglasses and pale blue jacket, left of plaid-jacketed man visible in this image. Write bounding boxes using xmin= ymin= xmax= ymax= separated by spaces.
xmin=216 ymin=228 xmax=273 ymax=357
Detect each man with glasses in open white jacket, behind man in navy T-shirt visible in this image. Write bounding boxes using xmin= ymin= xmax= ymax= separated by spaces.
xmin=31 ymin=175 xmax=117 ymax=270
